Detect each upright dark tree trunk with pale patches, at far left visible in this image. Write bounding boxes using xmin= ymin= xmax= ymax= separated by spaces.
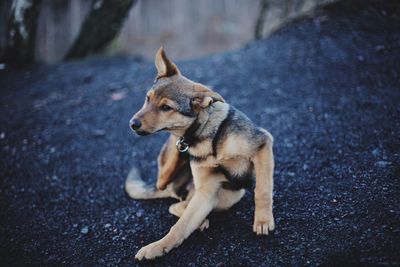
xmin=3 ymin=0 xmax=40 ymax=65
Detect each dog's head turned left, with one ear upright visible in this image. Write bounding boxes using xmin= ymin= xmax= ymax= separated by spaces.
xmin=130 ymin=47 xmax=224 ymax=136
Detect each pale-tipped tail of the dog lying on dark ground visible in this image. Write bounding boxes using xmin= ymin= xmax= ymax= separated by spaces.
xmin=125 ymin=166 xmax=173 ymax=199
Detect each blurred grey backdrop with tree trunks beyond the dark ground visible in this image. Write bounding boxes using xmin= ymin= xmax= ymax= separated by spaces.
xmin=0 ymin=0 xmax=333 ymax=64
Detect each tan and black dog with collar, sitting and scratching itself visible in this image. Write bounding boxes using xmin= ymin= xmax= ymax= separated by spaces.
xmin=125 ymin=47 xmax=275 ymax=261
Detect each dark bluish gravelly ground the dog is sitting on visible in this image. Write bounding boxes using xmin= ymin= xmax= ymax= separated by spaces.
xmin=0 ymin=0 xmax=400 ymax=266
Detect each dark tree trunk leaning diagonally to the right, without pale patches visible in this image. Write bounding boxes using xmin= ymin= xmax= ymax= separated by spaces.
xmin=65 ymin=0 xmax=136 ymax=59
